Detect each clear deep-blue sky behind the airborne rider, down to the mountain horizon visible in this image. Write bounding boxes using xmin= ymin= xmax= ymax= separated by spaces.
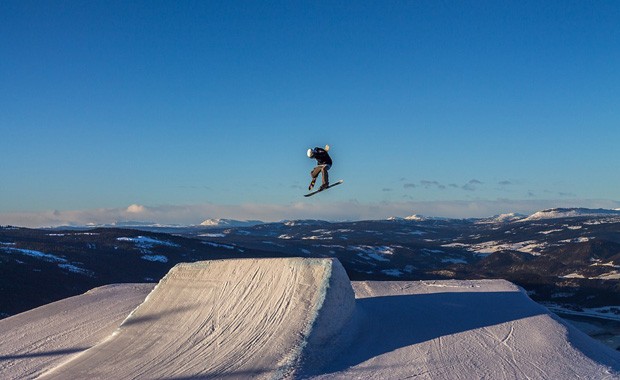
xmin=0 ymin=1 xmax=620 ymax=225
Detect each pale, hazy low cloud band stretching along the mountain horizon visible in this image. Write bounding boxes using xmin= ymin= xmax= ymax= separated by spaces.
xmin=0 ymin=199 xmax=620 ymax=227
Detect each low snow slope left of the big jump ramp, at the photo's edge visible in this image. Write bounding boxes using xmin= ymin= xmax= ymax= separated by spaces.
xmin=0 ymin=284 xmax=155 ymax=379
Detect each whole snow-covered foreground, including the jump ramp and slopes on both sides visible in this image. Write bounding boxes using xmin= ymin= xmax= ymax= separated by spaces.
xmin=0 ymin=258 xmax=620 ymax=380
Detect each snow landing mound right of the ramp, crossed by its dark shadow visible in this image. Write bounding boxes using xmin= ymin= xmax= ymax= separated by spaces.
xmin=314 ymin=280 xmax=620 ymax=380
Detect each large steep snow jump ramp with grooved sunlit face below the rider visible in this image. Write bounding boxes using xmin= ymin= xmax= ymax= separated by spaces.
xmin=42 ymin=258 xmax=355 ymax=379
